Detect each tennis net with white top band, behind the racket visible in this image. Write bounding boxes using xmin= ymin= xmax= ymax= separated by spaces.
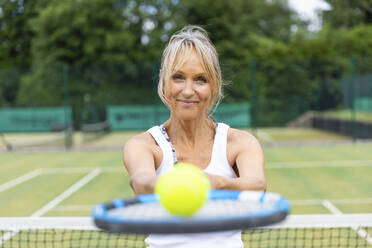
xmin=0 ymin=214 xmax=372 ymax=248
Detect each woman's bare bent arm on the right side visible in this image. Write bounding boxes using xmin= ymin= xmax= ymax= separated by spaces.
xmin=207 ymin=129 xmax=266 ymax=190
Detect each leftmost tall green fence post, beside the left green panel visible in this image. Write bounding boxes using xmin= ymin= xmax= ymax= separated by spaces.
xmin=62 ymin=64 xmax=72 ymax=150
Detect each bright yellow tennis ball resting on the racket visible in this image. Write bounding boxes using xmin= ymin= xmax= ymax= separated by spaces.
xmin=155 ymin=163 xmax=210 ymax=216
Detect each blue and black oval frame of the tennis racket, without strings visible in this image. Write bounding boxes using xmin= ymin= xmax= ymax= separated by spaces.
xmin=92 ymin=190 xmax=290 ymax=234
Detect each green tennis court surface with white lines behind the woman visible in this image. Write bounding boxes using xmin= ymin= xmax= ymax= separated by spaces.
xmin=0 ymin=129 xmax=372 ymax=247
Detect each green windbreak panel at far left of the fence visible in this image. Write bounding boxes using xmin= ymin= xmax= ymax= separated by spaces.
xmin=0 ymin=107 xmax=71 ymax=132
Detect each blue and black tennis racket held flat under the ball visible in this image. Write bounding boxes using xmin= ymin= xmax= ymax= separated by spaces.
xmin=92 ymin=190 xmax=290 ymax=234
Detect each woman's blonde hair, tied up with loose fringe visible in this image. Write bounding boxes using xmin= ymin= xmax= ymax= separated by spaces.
xmin=158 ymin=26 xmax=223 ymax=114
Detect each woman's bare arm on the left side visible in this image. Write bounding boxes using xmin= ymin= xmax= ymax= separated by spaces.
xmin=123 ymin=133 xmax=157 ymax=195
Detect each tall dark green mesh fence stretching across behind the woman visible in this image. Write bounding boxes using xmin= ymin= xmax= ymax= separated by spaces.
xmin=0 ymin=57 xmax=372 ymax=131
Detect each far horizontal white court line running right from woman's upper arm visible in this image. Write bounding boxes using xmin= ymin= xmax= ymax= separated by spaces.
xmin=265 ymin=160 xmax=372 ymax=169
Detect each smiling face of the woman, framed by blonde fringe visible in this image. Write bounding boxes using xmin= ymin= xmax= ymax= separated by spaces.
xmin=165 ymin=50 xmax=212 ymax=120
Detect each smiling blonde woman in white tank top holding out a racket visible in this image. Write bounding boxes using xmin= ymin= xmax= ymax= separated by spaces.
xmin=123 ymin=26 xmax=266 ymax=248
